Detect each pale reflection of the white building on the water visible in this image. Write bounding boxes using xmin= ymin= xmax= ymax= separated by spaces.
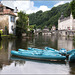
xmin=58 ymin=37 xmax=74 ymax=50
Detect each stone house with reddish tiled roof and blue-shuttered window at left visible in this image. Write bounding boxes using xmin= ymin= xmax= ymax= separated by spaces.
xmin=0 ymin=3 xmax=17 ymax=34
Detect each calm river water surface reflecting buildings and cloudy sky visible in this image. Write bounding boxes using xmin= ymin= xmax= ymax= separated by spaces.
xmin=0 ymin=35 xmax=75 ymax=74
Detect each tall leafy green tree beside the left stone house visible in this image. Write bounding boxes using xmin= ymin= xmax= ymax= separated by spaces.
xmin=16 ymin=11 xmax=28 ymax=36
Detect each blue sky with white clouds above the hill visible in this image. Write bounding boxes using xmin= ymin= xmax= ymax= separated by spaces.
xmin=0 ymin=0 xmax=71 ymax=14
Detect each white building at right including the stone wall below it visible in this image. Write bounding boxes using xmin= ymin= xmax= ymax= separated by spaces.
xmin=58 ymin=14 xmax=75 ymax=36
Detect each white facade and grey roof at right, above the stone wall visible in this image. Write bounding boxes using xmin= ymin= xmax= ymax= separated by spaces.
xmin=58 ymin=14 xmax=75 ymax=30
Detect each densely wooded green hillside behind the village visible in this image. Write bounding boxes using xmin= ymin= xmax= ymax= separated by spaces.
xmin=29 ymin=3 xmax=71 ymax=29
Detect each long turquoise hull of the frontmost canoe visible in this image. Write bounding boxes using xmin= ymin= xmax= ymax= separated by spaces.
xmin=11 ymin=51 xmax=66 ymax=61
